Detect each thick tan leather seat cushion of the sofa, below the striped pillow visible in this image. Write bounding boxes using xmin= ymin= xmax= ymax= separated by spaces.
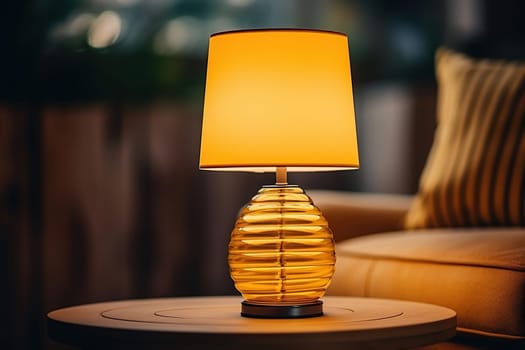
xmin=328 ymin=228 xmax=525 ymax=341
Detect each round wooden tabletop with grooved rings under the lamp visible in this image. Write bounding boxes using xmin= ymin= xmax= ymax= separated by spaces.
xmin=47 ymin=297 xmax=456 ymax=350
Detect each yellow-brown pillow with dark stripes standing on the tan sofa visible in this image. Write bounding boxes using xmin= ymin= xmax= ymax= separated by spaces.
xmin=405 ymin=48 xmax=525 ymax=228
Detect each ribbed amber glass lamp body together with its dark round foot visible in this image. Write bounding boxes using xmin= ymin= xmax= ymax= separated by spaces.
xmin=228 ymin=184 xmax=335 ymax=318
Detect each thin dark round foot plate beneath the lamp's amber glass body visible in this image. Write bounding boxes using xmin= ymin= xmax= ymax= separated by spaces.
xmin=241 ymin=300 xmax=323 ymax=318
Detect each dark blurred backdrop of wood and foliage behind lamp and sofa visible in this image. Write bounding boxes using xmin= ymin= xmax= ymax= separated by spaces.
xmin=0 ymin=0 xmax=525 ymax=349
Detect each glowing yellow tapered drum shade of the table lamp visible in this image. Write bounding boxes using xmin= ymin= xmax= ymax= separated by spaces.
xmin=200 ymin=29 xmax=359 ymax=172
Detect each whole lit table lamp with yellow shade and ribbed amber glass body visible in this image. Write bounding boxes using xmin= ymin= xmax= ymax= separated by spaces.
xmin=200 ymin=29 xmax=359 ymax=318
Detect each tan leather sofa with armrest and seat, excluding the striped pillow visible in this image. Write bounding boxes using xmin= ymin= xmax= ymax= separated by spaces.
xmin=308 ymin=190 xmax=525 ymax=349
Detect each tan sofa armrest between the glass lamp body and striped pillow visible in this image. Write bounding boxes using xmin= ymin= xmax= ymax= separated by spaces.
xmin=307 ymin=190 xmax=413 ymax=242
